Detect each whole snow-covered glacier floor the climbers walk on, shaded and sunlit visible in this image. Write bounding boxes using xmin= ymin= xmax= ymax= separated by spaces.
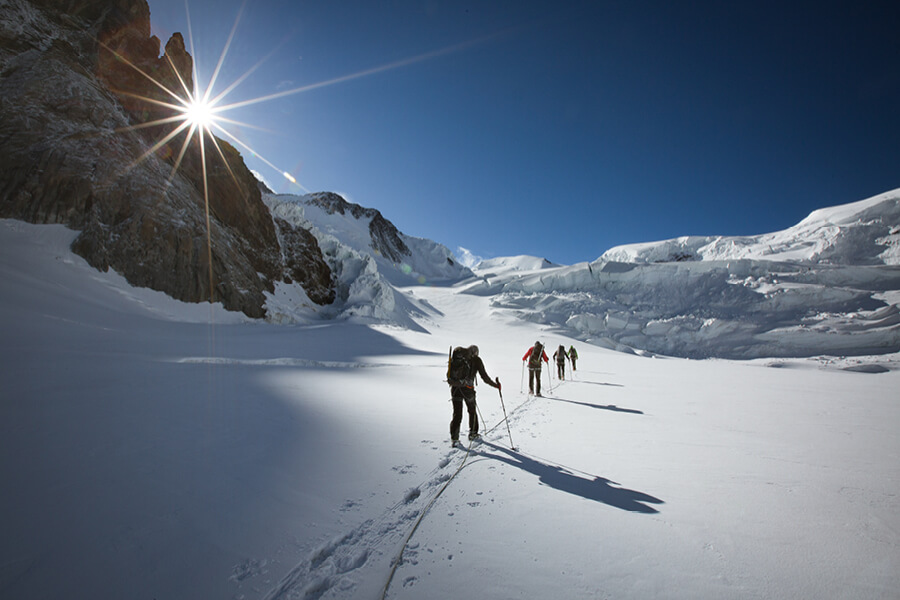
xmin=0 ymin=221 xmax=900 ymax=600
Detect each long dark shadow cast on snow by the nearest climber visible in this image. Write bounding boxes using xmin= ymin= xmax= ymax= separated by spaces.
xmin=472 ymin=441 xmax=664 ymax=514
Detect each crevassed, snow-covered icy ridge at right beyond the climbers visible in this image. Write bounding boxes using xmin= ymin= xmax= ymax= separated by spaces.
xmin=467 ymin=190 xmax=900 ymax=358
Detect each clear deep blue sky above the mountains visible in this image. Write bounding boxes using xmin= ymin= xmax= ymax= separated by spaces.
xmin=149 ymin=0 xmax=900 ymax=264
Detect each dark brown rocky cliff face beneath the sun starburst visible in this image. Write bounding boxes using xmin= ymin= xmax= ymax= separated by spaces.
xmin=0 ymin=0 xmax=334 ymax=317
